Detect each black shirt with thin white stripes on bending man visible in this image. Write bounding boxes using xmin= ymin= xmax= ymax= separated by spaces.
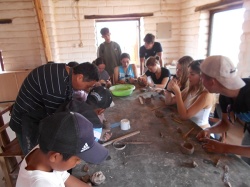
xmin=10 ymin=63 xmax=72 ymax=133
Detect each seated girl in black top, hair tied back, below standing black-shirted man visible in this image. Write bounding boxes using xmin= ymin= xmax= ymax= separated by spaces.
xmin=138 ymin=56 xmax=170 ymax=89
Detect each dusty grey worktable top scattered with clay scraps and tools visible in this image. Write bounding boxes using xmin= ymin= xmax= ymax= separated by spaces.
xmin=73 ymin=89 xmax=250 ymax=187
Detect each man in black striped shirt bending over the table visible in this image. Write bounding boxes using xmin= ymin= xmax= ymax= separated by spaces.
xmin=10 ymin=62 xmax=99 ymax=154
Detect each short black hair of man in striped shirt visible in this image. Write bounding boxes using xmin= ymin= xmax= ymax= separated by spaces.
xmin=73 ymin=62 xmax=99 ymax=82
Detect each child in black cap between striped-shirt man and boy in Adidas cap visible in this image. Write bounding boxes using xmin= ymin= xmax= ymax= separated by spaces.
xmin=56 ymin=86 xmax=112 ymax=141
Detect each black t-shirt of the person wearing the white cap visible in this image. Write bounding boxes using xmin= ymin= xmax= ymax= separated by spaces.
xmin=219 ymin=78 xmax=250 ymax=122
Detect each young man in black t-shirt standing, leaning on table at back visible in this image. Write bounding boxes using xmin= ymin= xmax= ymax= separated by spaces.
xmin=140 ymin=33 xmax=162 ymax=74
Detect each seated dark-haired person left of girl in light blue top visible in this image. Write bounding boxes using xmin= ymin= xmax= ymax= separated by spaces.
xmin=92 ymin=57 xmax=112 ymax=88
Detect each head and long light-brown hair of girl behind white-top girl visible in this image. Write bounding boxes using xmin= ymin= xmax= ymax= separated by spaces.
xmin=172 ymin=56 xmax=193 ymax=91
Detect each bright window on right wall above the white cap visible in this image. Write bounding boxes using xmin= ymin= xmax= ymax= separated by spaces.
xmin=208 ymin=7 xmax=245 ymax=66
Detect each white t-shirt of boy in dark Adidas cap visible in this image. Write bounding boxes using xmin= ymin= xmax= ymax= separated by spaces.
xmin=16 ymin=146 xmax=70 ymax=187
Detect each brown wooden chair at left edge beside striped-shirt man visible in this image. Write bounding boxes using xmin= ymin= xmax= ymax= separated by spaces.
xmin=0 ymin=104 xmax=24 ymax=187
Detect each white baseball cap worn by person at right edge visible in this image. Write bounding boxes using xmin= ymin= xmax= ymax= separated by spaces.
xmin=200 ymin=55 xmax=245 ymax=90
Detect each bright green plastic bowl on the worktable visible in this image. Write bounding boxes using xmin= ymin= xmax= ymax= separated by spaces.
xmin=109 ymin=84 xmax=135 ymax=96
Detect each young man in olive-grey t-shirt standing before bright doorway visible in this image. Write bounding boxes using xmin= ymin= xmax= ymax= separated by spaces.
xmin=97 ymin=27 xmax=121 ymax=78
